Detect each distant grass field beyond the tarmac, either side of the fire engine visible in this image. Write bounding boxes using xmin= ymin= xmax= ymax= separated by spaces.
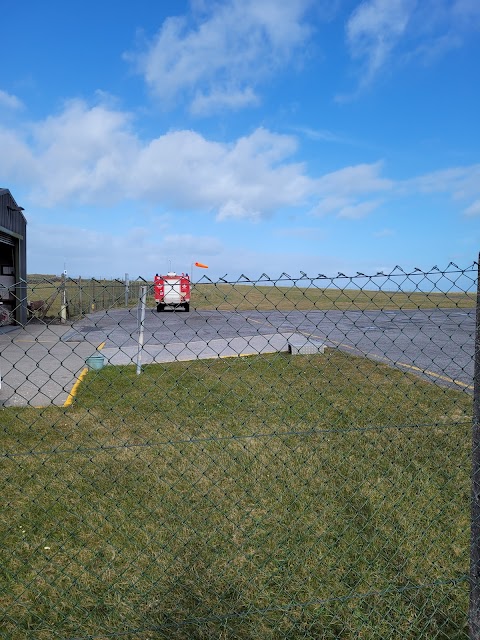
xmin=27 ymin=276 xmax=475 ymax=317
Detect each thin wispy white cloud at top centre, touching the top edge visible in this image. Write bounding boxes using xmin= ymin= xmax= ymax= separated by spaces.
xmin=125 ymin=0 xmax=313 ymax=114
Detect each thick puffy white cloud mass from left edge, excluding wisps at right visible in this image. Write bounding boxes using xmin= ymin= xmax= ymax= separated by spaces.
xmin=0 ymin=101 xmax=315 ymax=219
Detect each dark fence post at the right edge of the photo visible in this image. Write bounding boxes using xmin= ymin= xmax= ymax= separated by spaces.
xmin=469 ymin=254 xmax=480 ymax=640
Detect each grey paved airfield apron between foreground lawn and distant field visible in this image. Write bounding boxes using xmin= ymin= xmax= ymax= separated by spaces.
xmin=0 ymin=309 xmax=475 ymax=406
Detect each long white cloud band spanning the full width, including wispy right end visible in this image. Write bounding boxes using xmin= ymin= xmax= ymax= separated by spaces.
xmin=0 ymin=100 xmax=480 ymax=231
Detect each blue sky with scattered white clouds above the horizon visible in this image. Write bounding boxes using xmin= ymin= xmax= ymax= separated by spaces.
xmin=0 ymin=0 xmax=480 ymax=280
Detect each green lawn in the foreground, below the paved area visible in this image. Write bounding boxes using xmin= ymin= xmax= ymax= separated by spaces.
xmin=0 ymin=351 xmax=471 ymax=640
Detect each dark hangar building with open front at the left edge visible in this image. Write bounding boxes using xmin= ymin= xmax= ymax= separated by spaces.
xmin=0 ymin=187 xmax=27 ymax=326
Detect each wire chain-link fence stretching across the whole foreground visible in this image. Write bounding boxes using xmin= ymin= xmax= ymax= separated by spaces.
xmin=0 ymin=263 xmax=479 ymax=640
